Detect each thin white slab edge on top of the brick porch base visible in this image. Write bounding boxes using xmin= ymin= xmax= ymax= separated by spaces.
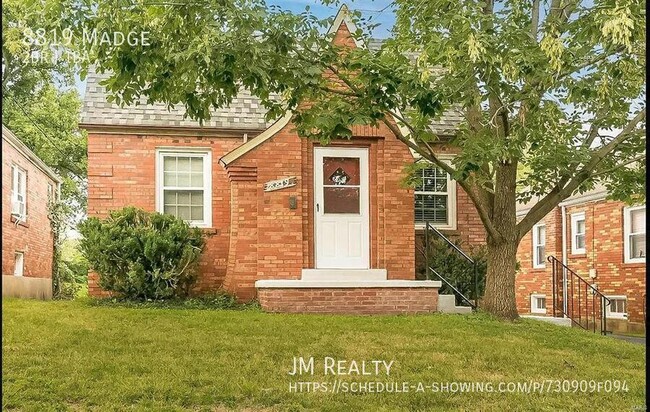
xmin=255 ymin=280 xmax=442 ymax=289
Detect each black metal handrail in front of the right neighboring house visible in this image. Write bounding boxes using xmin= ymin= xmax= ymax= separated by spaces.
xmin=547 ymin=256 xmax=612 ymax=335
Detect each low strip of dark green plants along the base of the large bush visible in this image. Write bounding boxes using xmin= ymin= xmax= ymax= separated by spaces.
xmin=90 ymin=291 xmax=259 ymax=310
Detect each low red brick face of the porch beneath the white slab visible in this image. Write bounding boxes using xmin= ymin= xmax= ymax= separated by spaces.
xmin=258 ymin=288 xmax=438 ymax=315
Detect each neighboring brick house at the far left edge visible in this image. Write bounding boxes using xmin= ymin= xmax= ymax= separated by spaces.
xmin=2 ymin=125 xmax=61 ymax=297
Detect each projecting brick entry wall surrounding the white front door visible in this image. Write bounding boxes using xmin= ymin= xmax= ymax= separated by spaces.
xmin=225 ymin=124 xmax=415 ymax=297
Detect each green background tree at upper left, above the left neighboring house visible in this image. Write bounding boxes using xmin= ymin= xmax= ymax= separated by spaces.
xmin=2 ymin=0 xmax=89 ymax=215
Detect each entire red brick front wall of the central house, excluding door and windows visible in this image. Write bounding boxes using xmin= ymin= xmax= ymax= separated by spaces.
xmin=82 ymin=16 xmax=484 ymax=300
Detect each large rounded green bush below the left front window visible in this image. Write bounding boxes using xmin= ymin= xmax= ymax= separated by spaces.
xmin=79 ymin=207 xmax=205 ymax=300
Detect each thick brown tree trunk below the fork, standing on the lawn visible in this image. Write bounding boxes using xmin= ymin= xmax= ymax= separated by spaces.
xmin=481 ymin=237 xmax=519 ymax=319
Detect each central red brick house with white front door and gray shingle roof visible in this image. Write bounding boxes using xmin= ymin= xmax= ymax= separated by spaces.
xmin=81 ymin=8 xmax=484 ymax=313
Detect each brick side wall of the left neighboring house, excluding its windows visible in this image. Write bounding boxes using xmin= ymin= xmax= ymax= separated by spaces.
xmin=2 ymin=139 xmax=56 ymax=278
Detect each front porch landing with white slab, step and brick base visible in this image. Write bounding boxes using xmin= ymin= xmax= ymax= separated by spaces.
xmin=255 ymin=269 xmax=442 ymax=315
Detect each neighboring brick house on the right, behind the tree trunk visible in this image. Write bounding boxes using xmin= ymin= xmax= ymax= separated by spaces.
xmin=516 ymin=187 xmax=646 ymax=331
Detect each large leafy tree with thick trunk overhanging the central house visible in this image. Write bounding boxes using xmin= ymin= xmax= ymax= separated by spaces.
xmin=78 ymin=0 xmax=646 ymax=318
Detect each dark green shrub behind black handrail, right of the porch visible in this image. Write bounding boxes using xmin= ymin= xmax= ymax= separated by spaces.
xmin=418 ymin=237 xmax=487 ymax=304
